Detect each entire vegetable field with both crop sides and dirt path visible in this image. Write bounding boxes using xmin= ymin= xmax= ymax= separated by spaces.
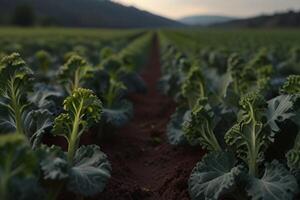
xmin=0 ymin=28 xmax=300 ymax=200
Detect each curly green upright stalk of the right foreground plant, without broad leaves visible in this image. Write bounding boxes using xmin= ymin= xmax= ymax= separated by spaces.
xmin=225 ymin=92 xmax=273 ymax=176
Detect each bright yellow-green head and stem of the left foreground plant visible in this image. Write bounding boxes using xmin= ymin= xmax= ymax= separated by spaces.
xmin=53 ymin=88 xmax=102 ymax=163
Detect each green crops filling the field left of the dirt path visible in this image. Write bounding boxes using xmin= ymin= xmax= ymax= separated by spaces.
xmin=0 ymin=29 xmax=152 ymax=200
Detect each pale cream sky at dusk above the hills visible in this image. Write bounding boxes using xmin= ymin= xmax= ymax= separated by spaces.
xmin=114 ymin=0 xmax=300 ymax=19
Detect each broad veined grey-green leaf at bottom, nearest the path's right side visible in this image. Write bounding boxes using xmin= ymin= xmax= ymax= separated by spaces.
xmin=188 ymin=152 xmax=240 ymax=200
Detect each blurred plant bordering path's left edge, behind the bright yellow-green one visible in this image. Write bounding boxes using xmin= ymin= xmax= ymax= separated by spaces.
xmin=95 ymin=54 xmax=136 ymax=128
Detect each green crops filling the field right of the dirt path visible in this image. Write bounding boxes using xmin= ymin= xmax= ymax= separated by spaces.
xmin=159 ymin=30 xmax=300 ymax=200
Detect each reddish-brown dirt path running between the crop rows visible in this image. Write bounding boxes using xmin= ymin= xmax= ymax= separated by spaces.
xmin=96 ymin=35 xmax=203 ymax=200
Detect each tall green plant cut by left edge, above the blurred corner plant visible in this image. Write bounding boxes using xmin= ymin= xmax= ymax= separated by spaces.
xmin=0 ymin=53 xmax=52 ymax=147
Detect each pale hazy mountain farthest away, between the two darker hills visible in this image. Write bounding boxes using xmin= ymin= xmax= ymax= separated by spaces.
xmin=179 ymin=15 xmax=238 ymax=26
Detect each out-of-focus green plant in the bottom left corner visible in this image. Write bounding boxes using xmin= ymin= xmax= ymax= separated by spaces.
xmin=0 ymin=134 xmax=45 ymax=200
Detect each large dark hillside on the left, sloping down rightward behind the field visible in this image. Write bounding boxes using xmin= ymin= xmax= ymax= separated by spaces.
xmin=0 ymin=0 xmax=183 ymax=28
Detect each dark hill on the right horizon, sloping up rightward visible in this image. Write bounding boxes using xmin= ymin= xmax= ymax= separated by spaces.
xmin=213 ymin=11 xmax=300 ymax=28
